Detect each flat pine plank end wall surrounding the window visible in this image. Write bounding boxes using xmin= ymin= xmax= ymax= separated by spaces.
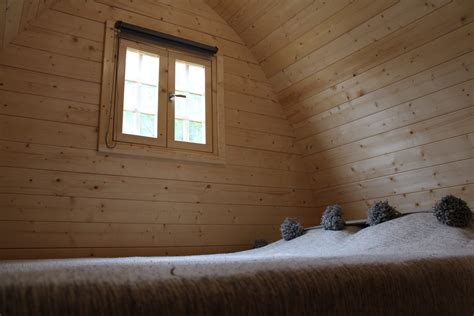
xmin=0 ymin=0 xmax=318 ymax=258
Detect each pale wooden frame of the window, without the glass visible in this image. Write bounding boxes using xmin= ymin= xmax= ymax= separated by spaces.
xmin=98 ymin=21 xmax=225 ymax=163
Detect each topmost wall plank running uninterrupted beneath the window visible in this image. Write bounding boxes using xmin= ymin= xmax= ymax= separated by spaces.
xmin=0 ymin=167 xmax=313 ymax=207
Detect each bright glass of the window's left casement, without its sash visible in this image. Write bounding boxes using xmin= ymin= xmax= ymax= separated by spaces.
xmin=122 ymin=47 xmax=160 ymax=138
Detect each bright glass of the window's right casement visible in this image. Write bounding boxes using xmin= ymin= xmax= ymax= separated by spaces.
xmin=175 ymin=60 xmax=206 ymax=144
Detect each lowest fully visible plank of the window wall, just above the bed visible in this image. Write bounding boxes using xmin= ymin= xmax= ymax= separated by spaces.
xmin=0 ymin=221 xmax=279 ymax=248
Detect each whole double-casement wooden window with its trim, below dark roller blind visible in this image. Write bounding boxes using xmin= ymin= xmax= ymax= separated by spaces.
xmin=99 ymin=22 xmax=225 ymax=162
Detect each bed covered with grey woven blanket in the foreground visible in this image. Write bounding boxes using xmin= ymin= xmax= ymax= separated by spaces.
xmin=0 ymin=213 xmax=474 ymax=315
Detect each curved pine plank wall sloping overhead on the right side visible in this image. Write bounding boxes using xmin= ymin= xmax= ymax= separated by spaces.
xmin=208 ymin=0 xmax=474 ymax=218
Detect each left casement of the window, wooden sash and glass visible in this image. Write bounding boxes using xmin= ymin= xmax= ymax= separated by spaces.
xmin=115 ymin=40 xmax=167 ymax=146
